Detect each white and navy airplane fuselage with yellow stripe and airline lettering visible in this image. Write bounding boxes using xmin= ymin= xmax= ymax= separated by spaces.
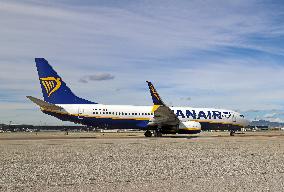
xmin=43 ymin=104 xmax=248 ymax=130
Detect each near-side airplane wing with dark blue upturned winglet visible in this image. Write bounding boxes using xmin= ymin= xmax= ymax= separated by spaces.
xmin=146 ymin=81 xmax=180 ymax=126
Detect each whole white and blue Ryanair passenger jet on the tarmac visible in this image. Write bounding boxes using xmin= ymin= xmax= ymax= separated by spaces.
xmin=27 ymin=58 xmax=248 ymax=137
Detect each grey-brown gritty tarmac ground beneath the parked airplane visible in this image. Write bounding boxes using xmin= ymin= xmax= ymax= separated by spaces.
xmin=0 ymin=132 xmax=284 ymax=191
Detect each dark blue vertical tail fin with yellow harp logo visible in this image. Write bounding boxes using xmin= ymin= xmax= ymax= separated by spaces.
xmin=35 ymin=58 xmax=96 ymax=104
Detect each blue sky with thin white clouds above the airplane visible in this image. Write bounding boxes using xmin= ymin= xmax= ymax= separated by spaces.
xmin=0 ymin=0 xmax=284 ymax=125
